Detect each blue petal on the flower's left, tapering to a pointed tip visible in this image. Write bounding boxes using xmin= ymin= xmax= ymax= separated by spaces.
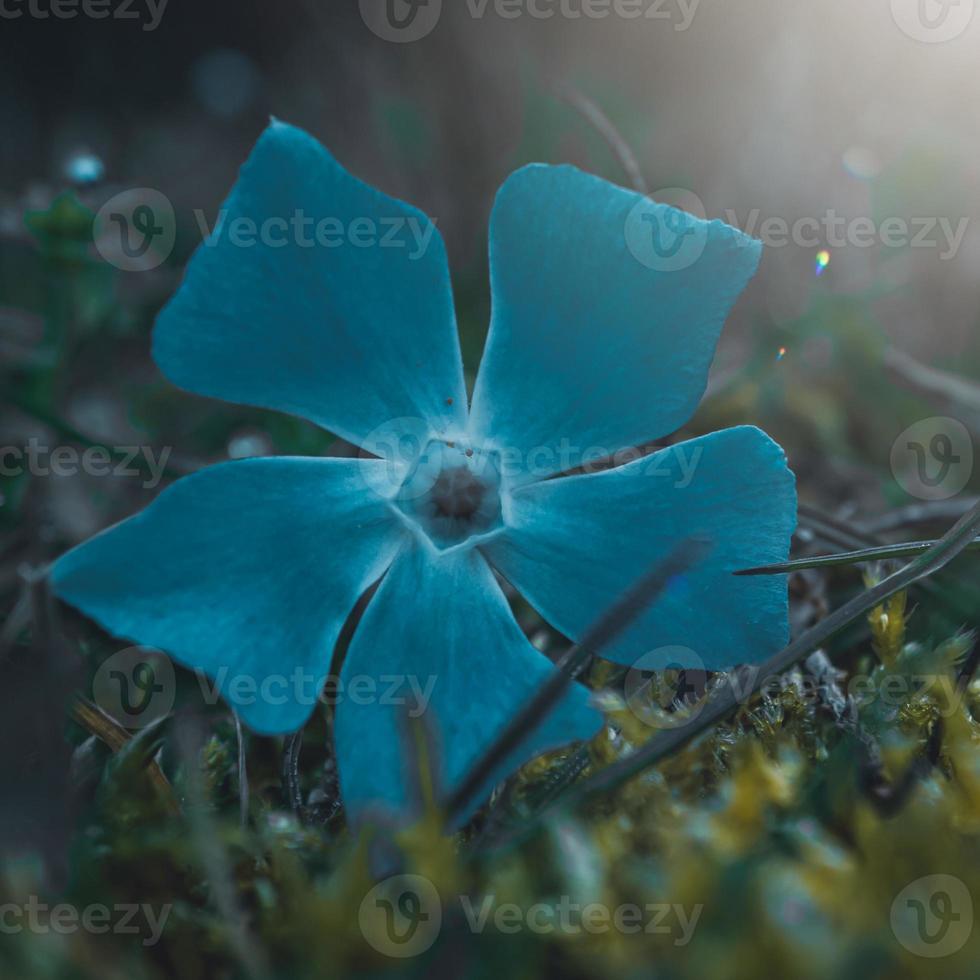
xmin=52 ymin=457 xmax=404 ymax=733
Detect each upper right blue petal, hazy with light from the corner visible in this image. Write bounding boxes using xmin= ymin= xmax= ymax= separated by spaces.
xmin=470 ymin=164 xmax=761 ymax=479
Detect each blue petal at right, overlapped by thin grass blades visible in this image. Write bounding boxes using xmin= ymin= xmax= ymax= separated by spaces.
xmin=481 ymin=426 xmax=796 ymax=670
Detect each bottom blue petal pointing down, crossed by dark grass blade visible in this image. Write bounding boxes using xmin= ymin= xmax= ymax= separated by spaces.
xmin=334 ymin=542 xmax=602 ymax=818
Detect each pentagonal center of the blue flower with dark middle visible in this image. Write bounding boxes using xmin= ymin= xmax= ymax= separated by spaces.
xmin=395 ymin=439 xmax=501 ymax=551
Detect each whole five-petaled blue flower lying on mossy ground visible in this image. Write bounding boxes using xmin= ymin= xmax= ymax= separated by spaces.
xmin=52 ymin=122 xmax=796 ymax=818
